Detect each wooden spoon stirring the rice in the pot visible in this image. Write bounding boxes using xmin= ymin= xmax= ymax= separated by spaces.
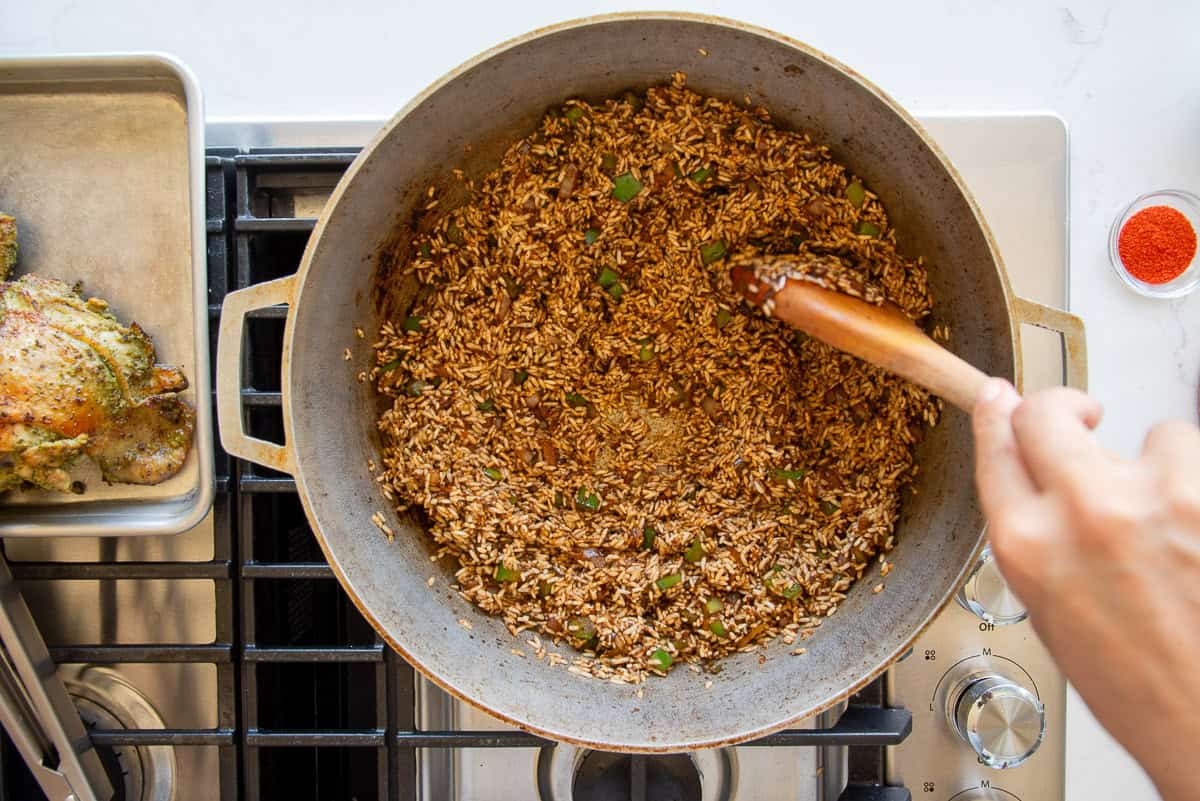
xmin=731 ymin=258 xmax=988 ymax=414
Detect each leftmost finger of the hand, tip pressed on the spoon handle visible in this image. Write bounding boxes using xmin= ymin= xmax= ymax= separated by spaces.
xmin=971 ymin=378 xmax=1037 ymax=519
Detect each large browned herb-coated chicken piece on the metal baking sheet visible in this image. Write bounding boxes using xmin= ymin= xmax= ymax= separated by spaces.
xmin=0 ymin=266 xmax=196 ymax=492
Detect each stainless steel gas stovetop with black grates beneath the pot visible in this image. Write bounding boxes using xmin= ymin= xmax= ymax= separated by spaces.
xmin=0 ymin=115 xmax=1067 ymax=801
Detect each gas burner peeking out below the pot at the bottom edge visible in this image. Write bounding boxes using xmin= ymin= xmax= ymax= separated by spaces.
xmin=538 ymin=745 xmax=736 ymax=801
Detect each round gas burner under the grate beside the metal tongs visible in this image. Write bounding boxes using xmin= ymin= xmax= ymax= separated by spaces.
xmin=61 ymin=666 xmax=175 ymax=801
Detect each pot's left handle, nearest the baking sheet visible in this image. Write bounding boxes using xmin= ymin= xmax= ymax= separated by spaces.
xmin=217 ymin=276 xmax=295 ymax=472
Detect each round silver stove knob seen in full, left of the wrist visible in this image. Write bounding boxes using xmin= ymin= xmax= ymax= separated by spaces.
xmin=947 ymin=674 xmax=1046 ymax=770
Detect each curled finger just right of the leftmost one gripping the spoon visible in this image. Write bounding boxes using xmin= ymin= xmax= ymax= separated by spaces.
xmin=1013 ymin=387 xmax=1110 ymax=490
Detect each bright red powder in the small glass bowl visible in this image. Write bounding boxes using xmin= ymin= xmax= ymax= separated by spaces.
xmin=1117 ymin=206 xmax=1196 ymax=284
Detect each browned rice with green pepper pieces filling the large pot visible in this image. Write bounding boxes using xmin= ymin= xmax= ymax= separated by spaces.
xmin=370 ymin=74 xmax=940 ymax=681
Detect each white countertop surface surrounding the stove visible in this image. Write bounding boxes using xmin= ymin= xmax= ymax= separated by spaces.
xmin=7 ymin=0 xmax=1200 ymax=801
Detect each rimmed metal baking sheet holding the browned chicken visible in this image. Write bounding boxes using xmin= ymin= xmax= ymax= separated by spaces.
xmin=0 ymin=54 xmax=214 ymax=537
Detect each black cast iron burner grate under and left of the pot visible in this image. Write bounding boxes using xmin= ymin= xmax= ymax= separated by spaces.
xmin=0 ymin=149 xmax=912 ymax=801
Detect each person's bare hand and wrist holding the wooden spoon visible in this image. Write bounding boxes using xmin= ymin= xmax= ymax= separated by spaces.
xmin=974 ymin=379 xmax=1200 ymax=801
